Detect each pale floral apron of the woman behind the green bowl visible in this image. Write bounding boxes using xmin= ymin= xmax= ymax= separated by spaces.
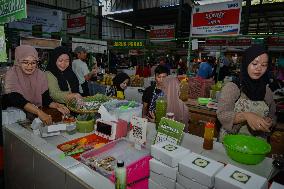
xmin=219 ymin=93 xmax=269 ymax=141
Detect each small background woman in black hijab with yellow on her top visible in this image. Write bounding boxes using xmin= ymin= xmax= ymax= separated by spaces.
xmin=106 ymin=72 xmax=130 ymax=99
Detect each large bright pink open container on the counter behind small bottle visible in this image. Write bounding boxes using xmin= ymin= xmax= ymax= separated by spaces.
xmin=81 ymin=138 xmax=152 ymax=184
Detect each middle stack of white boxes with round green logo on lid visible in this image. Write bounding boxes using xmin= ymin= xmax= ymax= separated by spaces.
xmin=176 ymin=153 xmax=224 ymax=189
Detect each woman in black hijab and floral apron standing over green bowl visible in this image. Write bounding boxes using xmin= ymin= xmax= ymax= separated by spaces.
xmin=217 ymin=45 xmax=276 ymax=140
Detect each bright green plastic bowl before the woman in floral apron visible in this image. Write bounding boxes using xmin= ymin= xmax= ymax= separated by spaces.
xmin=223 ymin=135 xmax=271 ymax=165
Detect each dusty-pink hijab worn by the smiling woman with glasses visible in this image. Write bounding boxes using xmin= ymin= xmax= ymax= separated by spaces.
xmin=5 ymin=45 xmax=48 ymax=106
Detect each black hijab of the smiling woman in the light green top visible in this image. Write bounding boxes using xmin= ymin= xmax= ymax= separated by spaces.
xmin=46 ymin=46 xmax=79 ymax=93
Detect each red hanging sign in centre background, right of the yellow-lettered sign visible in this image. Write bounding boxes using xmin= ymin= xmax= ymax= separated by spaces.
xmin=149 ymin=25 xmax=175 ymax=39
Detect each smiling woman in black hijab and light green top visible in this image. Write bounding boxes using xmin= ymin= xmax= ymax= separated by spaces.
xmin=46 ymin=47 xmax=81 ymax=104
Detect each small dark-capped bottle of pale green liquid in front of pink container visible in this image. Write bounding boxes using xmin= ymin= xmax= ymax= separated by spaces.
xmin=115 ymin=160 xmax=126 ymax=189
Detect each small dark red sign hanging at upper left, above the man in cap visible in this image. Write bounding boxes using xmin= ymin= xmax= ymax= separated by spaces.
xmin=67 ymin=13 xmax=86 ymax=33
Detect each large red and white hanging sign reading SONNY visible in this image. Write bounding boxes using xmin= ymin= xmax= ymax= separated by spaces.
xmin=191 ymin=0 xmax=242 ymax=37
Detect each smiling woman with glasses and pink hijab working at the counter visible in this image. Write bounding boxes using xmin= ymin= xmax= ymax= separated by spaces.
xmin=3 ymin=45 xmax=69 ymax=124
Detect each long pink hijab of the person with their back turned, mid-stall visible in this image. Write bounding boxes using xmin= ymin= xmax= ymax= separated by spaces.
xmin=164 ymin=76 xmax=189 ymax=132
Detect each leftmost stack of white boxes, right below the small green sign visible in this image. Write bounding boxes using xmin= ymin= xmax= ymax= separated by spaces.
xmin=149 ymin=142 xmax=190 ymax=189
